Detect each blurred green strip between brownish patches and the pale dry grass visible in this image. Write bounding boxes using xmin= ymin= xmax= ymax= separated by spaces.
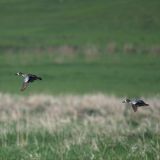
xmin=0 ymin=54 xmax=160 ymax=97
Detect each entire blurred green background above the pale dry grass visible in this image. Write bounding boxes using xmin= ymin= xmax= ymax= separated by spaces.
xmin=0 ymin=0 xmax=160 ymax=96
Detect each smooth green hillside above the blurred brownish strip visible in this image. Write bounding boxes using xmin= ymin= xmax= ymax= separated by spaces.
xmin=0 ymin=0 xmax=160 ymax=49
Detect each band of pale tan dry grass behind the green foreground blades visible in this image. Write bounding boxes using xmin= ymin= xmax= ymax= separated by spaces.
xmin=0 ymin=93 xmax=160 ymax=135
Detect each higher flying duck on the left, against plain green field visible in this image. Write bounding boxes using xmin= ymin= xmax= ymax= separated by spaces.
xmin=16 ymin=72 xmax=42 ymax=91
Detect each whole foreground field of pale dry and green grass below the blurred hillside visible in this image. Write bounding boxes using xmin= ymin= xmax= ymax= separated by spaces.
xmin=0 ymin=93 xmax=160 ymax=159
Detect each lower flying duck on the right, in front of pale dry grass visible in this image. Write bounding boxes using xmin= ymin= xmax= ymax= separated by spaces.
xmin=122 ymin=99 xmax=149 ymax=112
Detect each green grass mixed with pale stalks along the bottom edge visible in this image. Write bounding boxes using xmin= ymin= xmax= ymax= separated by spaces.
xmin=0 ymin=125 xmax=160 ymax=160
